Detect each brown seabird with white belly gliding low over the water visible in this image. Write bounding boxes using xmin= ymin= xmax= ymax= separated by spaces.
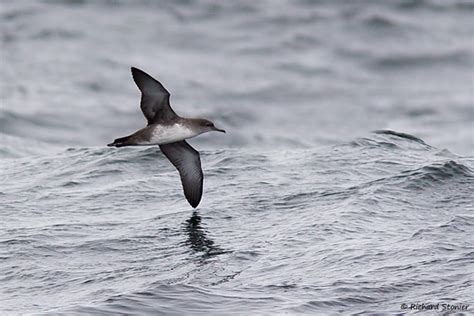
xmin=107 ymin=67 xmax=225 ymax=208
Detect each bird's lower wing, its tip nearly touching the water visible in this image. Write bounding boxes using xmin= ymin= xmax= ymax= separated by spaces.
xmin=160 ymin=140 xmax=204 ymax=208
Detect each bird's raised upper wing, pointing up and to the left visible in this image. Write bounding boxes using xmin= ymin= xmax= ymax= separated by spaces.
xmin=132 ymin=67 xmax=178 ymax=125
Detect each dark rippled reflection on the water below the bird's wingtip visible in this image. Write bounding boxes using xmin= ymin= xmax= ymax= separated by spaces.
xmin=184 ymin=211 xmax=226 ymax=260
